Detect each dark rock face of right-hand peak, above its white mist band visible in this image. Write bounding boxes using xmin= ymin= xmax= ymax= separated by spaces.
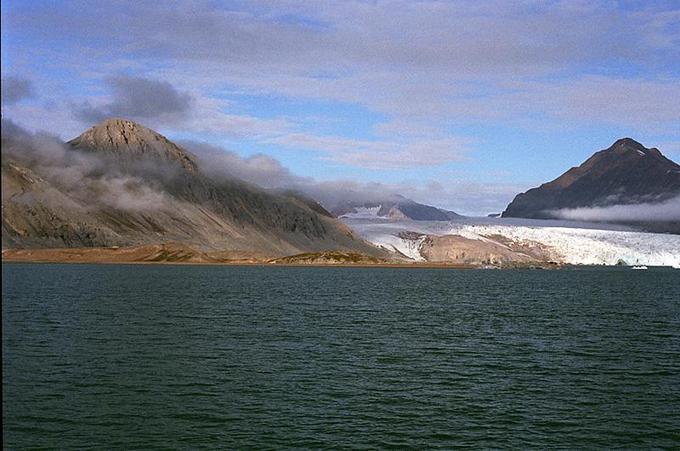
xmin=502 ymin=138 xmax=680 ymax=219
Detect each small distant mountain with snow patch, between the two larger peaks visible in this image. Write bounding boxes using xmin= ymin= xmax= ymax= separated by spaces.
xmin=331 ymin=194 xmax=462 ymax=221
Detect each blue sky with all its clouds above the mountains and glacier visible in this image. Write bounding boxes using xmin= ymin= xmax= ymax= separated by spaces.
xmin=1 ymin=0 xmax=680 ymax=215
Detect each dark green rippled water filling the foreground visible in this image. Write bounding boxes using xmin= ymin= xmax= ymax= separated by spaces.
xmin=2 ymin=264 xmax=680 ymax=449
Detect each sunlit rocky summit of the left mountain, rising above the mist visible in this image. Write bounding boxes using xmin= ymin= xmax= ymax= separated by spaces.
xmin=69 ymin=118 xmax=198 ymax=173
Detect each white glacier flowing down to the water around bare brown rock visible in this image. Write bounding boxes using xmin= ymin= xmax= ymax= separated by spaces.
xmin=343 ymin=218 xmax=680 ymax=267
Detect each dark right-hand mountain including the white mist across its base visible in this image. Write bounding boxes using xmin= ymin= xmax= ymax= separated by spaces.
xmin=503 ymin=138 xmax=680 ymax=230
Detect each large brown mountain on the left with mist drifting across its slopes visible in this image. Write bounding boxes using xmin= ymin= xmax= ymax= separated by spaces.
xmin=2 ymin=119 xmax=381 ymax=256
